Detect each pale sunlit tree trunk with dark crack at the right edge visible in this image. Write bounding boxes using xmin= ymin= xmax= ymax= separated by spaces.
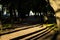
xmin=49 ymin=0 xmax=60 ymax=31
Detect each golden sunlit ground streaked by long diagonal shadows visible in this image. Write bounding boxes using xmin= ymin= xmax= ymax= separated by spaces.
xmin=1 ymin=24 xmax=56 ymax=40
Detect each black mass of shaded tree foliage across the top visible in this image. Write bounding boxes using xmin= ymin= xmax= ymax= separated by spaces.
xmin=1 ymin=0 xmax=55 ymax=24
